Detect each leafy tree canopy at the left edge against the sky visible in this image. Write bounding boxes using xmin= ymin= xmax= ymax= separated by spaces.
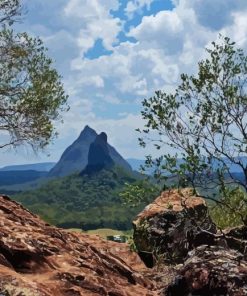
xmin=0 ymin=0 xmax=67 ymax=149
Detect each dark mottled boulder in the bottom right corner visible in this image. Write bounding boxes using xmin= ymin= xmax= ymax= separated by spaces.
xmin=164 ymin=245 xmax=247 ymax=296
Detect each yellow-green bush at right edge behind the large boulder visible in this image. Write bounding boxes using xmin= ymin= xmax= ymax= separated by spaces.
xmin=209 ymin=188 xmax=247 ymax=229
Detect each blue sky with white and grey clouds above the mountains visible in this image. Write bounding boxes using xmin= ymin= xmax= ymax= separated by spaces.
xmin=0 ymin=0 xmax=247 ymax=166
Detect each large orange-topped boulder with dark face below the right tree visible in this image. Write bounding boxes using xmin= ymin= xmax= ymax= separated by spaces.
xmin=133 ymin=189 xmax=216 ymax=267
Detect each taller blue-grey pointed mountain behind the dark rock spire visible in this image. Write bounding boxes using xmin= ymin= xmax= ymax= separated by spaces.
xmin=48 ymin=125 xmax=132 ymax=177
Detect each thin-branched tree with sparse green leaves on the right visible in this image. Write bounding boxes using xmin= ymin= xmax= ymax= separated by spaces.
xmin=139 ymin=36 xmax=247 ymax=227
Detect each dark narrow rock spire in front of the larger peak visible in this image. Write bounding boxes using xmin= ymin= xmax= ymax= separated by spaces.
xmin=81 ymin=133 xmax=114 ymax=175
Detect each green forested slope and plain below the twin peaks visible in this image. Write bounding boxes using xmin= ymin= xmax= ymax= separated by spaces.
xmin=13 ymin=167 xmax=151 ymax=230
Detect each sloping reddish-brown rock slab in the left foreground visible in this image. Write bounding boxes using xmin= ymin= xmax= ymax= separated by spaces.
xmin=0 ymin=196 xmax=157 ymax=296
